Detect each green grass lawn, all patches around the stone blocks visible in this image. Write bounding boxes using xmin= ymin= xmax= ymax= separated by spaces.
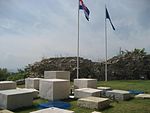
xmin=14 ymin=80 xmax=150 ymax=113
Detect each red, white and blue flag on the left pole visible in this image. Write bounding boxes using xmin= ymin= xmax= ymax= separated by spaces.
xmin=79 ymin=0 xmax=90 ymax=21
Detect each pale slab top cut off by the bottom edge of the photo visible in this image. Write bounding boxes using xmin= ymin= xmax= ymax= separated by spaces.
xmin=30 ymin=107 xmax=75 ymax=113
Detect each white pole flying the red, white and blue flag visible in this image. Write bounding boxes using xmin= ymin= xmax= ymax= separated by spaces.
xmin=77 ymin=0 xmax=80 ymax=79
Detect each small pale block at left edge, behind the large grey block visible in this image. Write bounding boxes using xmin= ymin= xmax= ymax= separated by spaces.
xmin=0 ymin=81 xmax=16 ymax=90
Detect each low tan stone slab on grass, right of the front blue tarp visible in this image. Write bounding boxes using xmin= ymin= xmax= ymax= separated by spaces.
xmin=77 ymin=97 xmax=110 ymax=110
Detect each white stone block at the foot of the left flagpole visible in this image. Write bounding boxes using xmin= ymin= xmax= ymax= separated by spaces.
xmin=74 ymin=78 xmax=97 ymax=89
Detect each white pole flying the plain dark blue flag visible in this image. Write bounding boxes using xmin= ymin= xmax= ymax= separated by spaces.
xmin=105 ymin=5 xmax=107 ymax=82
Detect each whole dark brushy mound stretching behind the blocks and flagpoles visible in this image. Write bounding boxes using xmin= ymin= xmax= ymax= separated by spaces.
xmin=0 ymin=49 xmax=150 ymax=81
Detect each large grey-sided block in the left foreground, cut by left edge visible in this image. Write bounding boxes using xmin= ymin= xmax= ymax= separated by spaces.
xmin=0 ymin=89 xmax=33 ymax=110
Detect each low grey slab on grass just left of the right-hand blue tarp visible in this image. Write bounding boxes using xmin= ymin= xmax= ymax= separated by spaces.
xmin=106 ymin=90 xmax=132 ymax=100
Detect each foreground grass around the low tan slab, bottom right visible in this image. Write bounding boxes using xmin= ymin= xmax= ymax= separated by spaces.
xmin=68 ymin=99 xmax=150 ymax=113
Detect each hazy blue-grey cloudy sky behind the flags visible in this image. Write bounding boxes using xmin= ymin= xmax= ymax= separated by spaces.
xmin=0 ymin=0 xmax=150 ymax=70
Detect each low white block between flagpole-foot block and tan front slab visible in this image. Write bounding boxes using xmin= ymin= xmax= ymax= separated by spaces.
xmin=74 ymin=88 xmax=101 ymax=98
